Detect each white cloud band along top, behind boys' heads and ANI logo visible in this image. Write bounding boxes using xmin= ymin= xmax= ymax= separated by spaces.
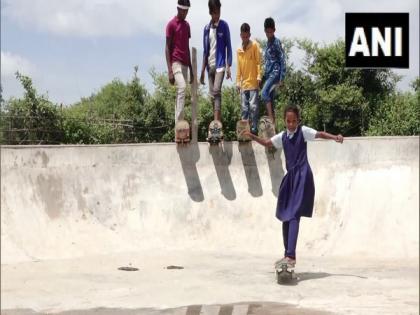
xmin=2 ymin=0 xmax=418 ymax=47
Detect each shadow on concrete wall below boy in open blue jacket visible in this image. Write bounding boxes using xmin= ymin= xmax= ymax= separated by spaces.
xmin=209 ymin=142 xmax=236 ymax=200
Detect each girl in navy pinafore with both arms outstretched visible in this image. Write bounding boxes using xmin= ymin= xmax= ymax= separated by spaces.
xmin=243 ymin=106 xmax=343 ymax=268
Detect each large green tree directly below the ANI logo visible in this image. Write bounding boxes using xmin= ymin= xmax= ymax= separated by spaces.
xmin=291 ymin=40 xmax=399 ymax=136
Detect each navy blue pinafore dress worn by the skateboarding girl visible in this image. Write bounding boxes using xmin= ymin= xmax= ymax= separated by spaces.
xmin=276 ymin=126 xmax=315 ymax=222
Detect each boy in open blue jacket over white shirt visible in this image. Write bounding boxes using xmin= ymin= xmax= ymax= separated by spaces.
xmin=200 ymin=0 xmax=232 ymax=126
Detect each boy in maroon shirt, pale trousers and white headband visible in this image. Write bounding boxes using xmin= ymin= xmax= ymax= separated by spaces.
xmin=165 ymin=0 xmax=194 ymax=123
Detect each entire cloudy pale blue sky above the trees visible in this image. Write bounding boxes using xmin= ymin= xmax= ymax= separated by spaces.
xmin=1 ymin=0 xmax=419 ymax=105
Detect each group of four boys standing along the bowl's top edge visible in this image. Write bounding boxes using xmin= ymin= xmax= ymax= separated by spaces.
xmin=165 ymin=0 xmax=286 ymax=139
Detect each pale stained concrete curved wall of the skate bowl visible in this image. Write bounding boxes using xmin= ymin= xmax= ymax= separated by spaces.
xmin=1 ymin=137 xmax=419 ymax=264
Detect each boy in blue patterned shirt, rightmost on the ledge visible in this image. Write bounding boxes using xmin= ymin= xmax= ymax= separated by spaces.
xmin=261 ymin=17 xmax=286 ymax=126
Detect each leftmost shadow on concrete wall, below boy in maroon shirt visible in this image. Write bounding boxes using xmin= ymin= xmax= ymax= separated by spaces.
xmin=176 ymin=143 xmax=204 ymax=202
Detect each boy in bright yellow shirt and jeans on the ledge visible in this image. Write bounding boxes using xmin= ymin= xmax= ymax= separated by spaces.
xmin=236 ymin=23 xmax=261 ymax=135
